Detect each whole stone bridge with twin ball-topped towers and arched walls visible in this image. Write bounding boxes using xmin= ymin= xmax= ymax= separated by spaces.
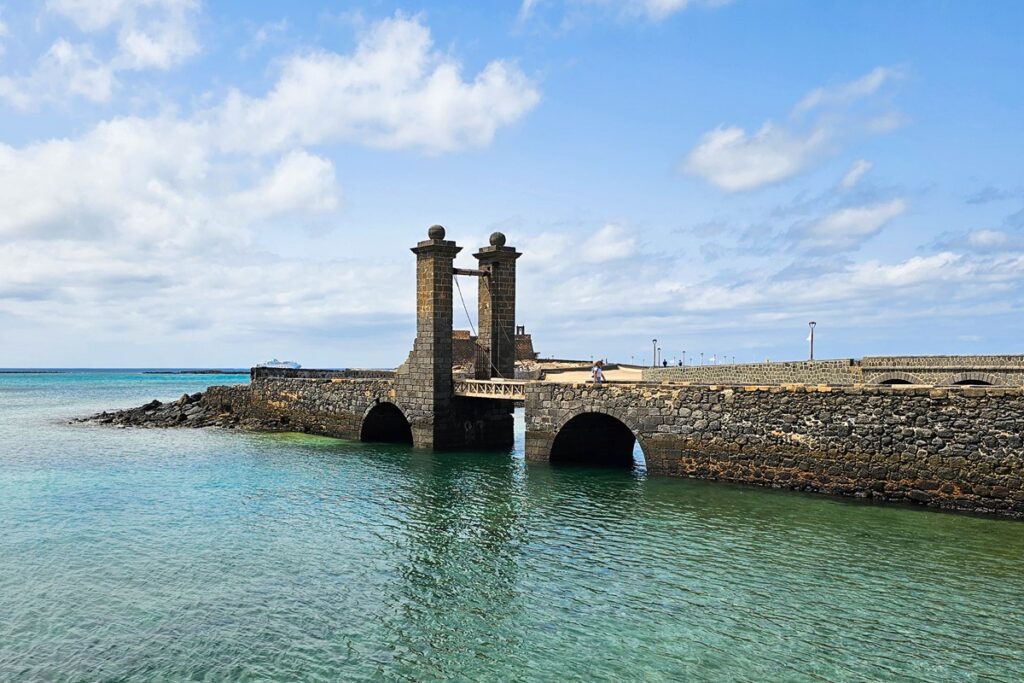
xmin=186 ymin=226 xmax=1024 ymax=516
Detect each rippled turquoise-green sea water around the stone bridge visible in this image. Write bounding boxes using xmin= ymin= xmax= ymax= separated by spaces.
xmin=0 ymin=373 xmax=1024 ymax=681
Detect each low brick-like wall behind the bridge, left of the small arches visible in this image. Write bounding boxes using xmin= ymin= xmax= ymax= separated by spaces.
xmin=642 ymin=358 xmax=862 ymax=386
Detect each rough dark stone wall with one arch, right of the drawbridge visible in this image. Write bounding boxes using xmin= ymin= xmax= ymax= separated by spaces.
xmin=525 ymin=383 xmax=1024 ymax=516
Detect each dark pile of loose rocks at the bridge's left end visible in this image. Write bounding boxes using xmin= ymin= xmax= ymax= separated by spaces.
xmin=76 ymin=385 xmax=268 ymax=430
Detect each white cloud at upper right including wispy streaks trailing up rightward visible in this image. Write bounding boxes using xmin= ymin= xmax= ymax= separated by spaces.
xmin=683 ymin=67 xmax=902 ymax=191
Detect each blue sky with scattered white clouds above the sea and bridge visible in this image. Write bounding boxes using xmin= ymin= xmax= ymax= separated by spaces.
xmin=0 ymin=0 xmax=1024 ymax=368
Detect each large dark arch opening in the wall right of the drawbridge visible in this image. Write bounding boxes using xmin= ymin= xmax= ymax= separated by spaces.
xmin=550 ymin=413 xmax=644 ymax=470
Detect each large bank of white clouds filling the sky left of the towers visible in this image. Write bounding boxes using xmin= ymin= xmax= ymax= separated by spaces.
xmin=0 ymin=12 xmax=544 ymax=361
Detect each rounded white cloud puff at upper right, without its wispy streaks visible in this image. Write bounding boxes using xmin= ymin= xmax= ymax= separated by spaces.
xmin=685 ymin=123 xmax=830 ymax=191
